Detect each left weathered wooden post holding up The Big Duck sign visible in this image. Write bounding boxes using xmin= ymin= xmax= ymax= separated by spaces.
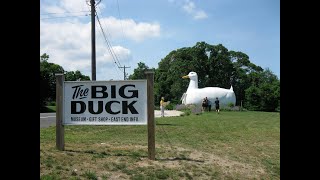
xmin=56 ymin=74 xmax=64 ymax=151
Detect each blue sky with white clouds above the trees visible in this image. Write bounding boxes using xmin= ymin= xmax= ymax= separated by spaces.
xmin=40 ymin=0 xmax=280 ymax=81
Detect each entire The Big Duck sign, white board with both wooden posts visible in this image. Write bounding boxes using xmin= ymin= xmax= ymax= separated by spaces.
xmin=56 ymin=74 xmax=155 ymax=160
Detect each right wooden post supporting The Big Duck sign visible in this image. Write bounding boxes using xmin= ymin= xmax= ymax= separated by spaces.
xmin=145 ymin=70 xmax=156 ymax=160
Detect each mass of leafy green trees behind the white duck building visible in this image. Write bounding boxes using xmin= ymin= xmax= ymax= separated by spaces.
xmin=129 ymin=42 xmax=280 ymax=111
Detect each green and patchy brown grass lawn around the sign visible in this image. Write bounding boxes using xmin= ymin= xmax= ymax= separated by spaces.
xmin=40 ymin=111 xmax=280 ymax=179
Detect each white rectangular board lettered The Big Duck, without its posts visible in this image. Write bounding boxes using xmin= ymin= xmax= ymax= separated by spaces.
xmin=63 ymin=80 xmax=147 ymax=125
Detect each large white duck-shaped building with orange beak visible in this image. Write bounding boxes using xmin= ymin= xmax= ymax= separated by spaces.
xmin=181 ymin=72 xmax=236 ymax=107
